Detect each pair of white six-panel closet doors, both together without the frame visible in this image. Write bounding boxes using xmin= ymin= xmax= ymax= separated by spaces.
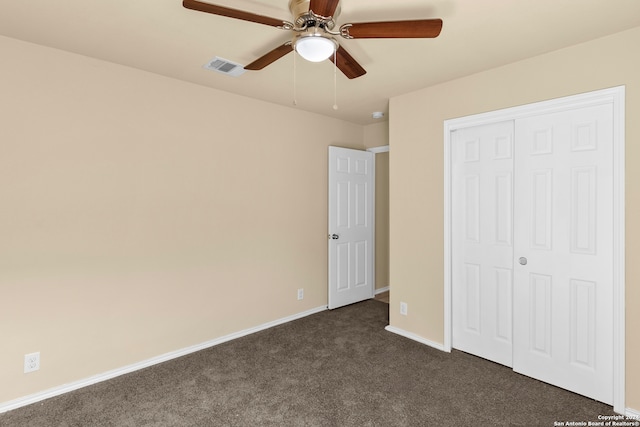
xmin=451 ymin=104 xmax=614 ymax=404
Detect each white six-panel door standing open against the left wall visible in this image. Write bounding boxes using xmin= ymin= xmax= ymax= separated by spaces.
xmin=328 ymin=147 xmax=375 ymax=309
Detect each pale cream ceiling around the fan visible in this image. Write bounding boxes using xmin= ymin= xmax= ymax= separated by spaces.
xmin=0 ymin=0 xmax=640 ymax=124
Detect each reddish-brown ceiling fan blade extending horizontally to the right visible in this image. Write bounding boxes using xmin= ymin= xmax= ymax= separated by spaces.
xmin=341 ymin=19 xmax=442 ymax=39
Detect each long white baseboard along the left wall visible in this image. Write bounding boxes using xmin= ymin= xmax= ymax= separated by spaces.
xmin=0 ymin=305 xmax=327 ymax=414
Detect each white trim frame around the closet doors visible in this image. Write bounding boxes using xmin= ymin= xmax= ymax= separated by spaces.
xmin=443 ymin=86 xmax=626 ymax=414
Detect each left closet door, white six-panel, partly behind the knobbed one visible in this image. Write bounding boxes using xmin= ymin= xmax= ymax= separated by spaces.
xmin=451 ymin=121 xmax=514 ymax=366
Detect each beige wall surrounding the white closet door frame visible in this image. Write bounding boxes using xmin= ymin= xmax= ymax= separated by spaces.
xmin=389 ymin=28 xmax=640 ymax=410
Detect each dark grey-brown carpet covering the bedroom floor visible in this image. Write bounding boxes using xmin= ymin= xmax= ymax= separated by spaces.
xmin=0 ymin=300 xmax=613 ymax=427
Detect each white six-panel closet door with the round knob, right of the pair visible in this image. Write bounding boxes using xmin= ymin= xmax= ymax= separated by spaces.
xmin=513 ymin=104 xmax=613 ymax=404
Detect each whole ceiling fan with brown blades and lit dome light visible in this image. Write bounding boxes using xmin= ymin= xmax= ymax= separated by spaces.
xmin=182 ymin=0 xmax=442 ymax=79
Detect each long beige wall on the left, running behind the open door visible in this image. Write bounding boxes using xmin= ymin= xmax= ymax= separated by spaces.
xmin=0 ymin=37 xmax=364 ymax=403
